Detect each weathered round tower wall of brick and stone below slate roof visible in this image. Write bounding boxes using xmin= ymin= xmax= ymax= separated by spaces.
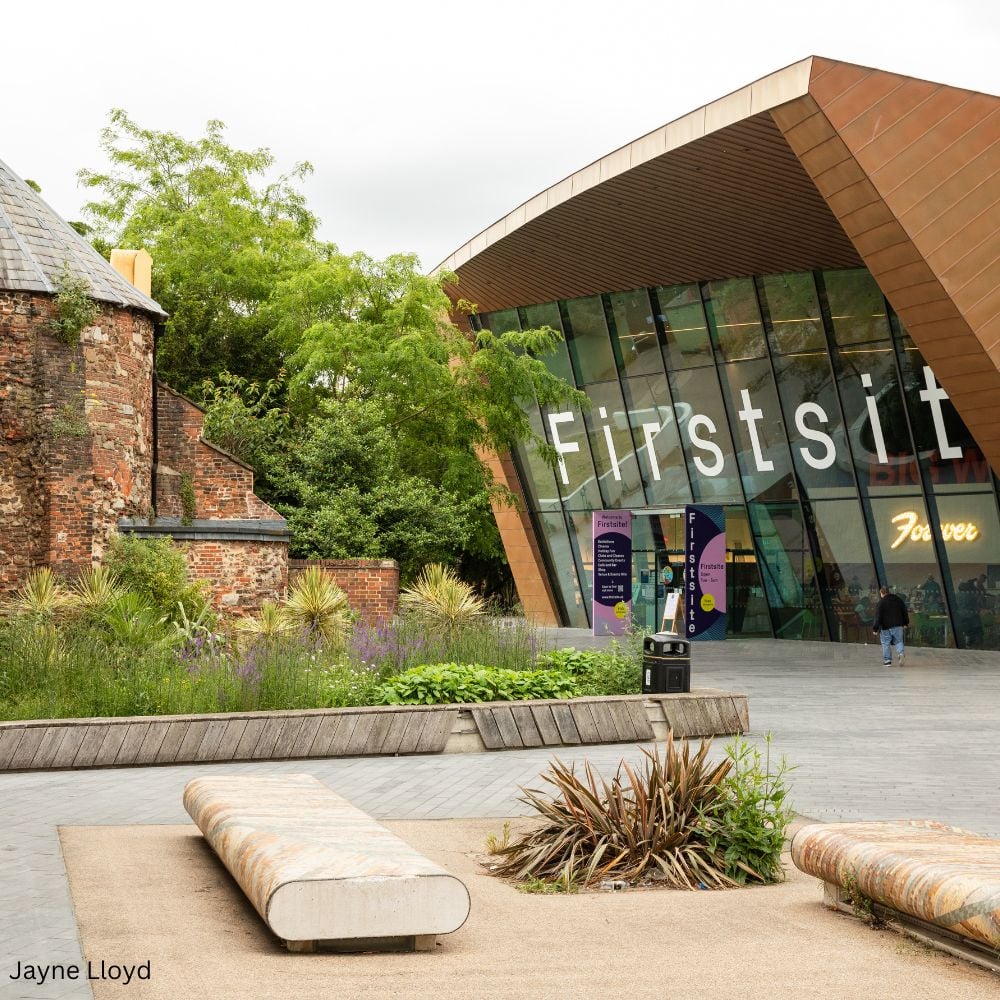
xmin=0 ymin=291 xmax=153 ymax=593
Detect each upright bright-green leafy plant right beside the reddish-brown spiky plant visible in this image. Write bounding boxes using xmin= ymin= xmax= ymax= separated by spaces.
xmin=704 ymin=733 xmax=794 ymax=883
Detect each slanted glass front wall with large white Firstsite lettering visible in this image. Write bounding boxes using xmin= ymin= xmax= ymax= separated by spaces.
xmin=490 ymin=268 xmax=1000 ymax=649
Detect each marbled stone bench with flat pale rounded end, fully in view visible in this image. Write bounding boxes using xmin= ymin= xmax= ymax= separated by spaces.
xmin=184 ymin=774 xmax=469 ymax=951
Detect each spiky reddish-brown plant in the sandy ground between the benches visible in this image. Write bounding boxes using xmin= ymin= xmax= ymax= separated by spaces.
xmin=495 ymin=733 xmax=735 ymax=889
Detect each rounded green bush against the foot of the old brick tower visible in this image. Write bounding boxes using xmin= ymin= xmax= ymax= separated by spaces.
xmin=104 ymin=535 xmax=208 ymax=621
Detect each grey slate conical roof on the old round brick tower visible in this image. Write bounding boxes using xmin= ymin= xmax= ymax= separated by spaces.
xmin=0 ymin=160 xmax=166 ymax=316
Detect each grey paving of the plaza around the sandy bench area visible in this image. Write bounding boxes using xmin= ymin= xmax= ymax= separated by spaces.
xmin=0 ymin=630 xmax=1000 ymax=1000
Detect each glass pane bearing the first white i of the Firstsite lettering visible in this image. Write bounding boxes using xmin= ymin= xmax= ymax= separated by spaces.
xmin=584 ymin=381 xmax=646 ymax=508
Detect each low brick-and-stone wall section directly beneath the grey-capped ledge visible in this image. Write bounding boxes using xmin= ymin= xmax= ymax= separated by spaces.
xmin=185 ymin=539 xmax=288 ymax=615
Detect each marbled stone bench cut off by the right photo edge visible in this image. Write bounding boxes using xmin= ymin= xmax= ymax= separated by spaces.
xmin=792 ymin=820 xmax=1000 ymax=967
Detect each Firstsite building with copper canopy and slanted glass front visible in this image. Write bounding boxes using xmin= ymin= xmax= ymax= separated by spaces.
xmin=441 ymin=57 xmax=1000 ymax=649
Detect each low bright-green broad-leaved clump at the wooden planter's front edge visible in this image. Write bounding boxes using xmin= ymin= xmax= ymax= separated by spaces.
xmin=379 ymin=663 xmax=576 ymax=705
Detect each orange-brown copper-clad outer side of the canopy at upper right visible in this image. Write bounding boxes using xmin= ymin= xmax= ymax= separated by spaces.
xmin=771 ymin=59 xmax=1000 ymax=473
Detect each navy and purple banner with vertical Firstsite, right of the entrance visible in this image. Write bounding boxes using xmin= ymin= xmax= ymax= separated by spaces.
xmin=684 ymin=504 xmax=726 ymax=639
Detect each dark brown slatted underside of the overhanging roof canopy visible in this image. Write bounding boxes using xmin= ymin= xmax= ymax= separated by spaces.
xmin=449 ymin=113 xmax=861 ymax=312
